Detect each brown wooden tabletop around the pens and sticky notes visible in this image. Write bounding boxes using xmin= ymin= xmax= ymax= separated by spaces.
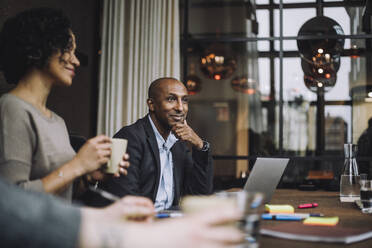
xmin=260 ymin=189 xmax=372 ymax=248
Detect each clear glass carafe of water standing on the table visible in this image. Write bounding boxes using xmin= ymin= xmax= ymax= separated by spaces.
xmin=340 ymin=144 xmax=360 ymax=202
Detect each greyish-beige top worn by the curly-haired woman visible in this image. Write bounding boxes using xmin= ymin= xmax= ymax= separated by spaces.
xmin=0 ymin=94 xmax=75 ymax=201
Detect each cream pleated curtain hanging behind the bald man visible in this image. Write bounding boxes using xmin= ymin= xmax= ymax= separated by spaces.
xmin=97 ymin=0 xmax=180 ymax=136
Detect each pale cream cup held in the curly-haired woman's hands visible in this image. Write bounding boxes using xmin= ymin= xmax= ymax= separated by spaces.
xmin=105 ymin=138 xmax=128 ymax=174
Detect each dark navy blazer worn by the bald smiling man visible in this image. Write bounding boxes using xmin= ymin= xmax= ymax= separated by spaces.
xmin=103 ymin=115 xmax=213 ymax=206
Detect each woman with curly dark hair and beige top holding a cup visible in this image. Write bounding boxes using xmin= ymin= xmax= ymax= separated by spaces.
xmin=0 ymin=8 xmax=129 ymax=200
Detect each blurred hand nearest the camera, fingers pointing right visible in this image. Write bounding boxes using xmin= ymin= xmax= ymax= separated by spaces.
xmin=123 ymin=208 xmax=245 ymax=248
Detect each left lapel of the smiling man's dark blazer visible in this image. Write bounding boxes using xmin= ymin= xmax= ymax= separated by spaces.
xmin=143 ymin=115 xmax=161 ymax=199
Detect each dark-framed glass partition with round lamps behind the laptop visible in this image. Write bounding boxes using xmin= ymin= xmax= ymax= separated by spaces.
xmin=180 ymin=0 xmax=372 ymax=187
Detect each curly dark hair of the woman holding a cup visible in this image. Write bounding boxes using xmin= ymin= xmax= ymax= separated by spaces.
xmin=0 ymin=8 xmax=72 ymax=84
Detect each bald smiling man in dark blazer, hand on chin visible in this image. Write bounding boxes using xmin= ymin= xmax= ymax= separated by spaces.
xmin=99 ymin=78 xmax=213 ymax=210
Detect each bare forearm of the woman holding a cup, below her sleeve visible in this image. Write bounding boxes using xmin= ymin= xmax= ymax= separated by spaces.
xmin=41 ymin=158 xmax=85 ymax=194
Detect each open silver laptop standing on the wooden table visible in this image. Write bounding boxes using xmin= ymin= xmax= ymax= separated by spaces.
xmin=244 ymin=158 xmax=289 ymax=203
